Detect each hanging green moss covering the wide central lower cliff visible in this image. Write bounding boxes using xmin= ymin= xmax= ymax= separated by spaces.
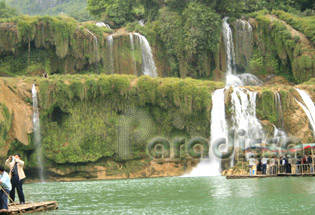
xmin=37 ymin=75 xmax=223 ymax=163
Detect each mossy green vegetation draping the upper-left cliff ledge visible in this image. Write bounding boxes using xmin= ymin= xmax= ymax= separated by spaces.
xmin=0 ymin=15 xmax=116 ymax=76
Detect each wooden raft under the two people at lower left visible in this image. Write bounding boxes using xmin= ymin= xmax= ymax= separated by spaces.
xmin=0 ymin=201 xmax=58 ymax=215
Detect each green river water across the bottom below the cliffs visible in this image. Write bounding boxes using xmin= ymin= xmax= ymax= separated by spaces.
xmin=24 ymin=177 xmax=315 ymax=215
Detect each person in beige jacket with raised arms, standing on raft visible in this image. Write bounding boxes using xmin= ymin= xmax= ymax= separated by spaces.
xmin=5 ymin=154 xmax=25 ymax=204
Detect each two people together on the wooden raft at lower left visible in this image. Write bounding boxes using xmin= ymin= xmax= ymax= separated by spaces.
xmin=0 ymin=154 xmax=25 ymax=209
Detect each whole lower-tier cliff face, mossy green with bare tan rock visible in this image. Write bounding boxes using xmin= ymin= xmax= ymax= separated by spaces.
xmin=0 ymin=75 xmax=315 ymax=180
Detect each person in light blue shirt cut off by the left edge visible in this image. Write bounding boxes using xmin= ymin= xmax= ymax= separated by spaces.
xmin=0 ymin=166 xmax=11 ymax=209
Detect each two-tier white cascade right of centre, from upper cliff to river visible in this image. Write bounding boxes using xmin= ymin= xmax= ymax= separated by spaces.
xmin=185 ymin=17 xmax=264 ymax=176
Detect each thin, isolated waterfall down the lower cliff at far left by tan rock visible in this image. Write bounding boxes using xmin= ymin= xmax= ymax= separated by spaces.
xmin=32 ymin=84 xmax=44 ymax=182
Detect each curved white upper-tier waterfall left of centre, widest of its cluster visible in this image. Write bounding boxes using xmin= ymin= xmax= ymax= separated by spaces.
xmin=134 ymin=33 xmax=158 ymax=77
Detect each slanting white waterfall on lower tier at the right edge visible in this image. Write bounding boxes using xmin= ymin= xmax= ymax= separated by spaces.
xmin=295 ymin=88 xmax=315 ymax=137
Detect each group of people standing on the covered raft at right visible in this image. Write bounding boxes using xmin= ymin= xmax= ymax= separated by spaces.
xmin=248 ymin=155 xmax=315 ymax=175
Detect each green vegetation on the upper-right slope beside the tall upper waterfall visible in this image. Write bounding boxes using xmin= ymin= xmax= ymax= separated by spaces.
xmin=249 ymin=11 xmax=315 ymax=83
